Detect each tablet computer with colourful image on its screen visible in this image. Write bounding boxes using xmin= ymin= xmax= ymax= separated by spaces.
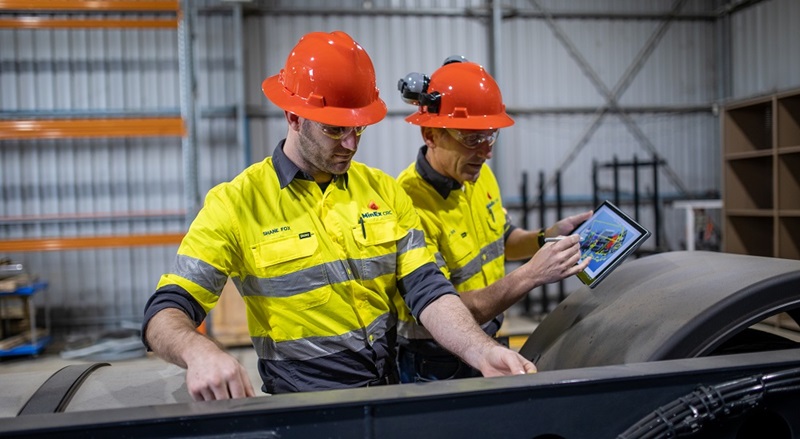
xmin=572 ymin=200 xmax=650 ymax=288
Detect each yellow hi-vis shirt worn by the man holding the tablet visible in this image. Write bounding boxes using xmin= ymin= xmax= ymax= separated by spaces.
xmin=397 ymin=153 xmax=510 ymax=342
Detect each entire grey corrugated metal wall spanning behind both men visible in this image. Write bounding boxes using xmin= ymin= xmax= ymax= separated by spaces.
xmin=0 ymin=0 xmax=800 ymax=331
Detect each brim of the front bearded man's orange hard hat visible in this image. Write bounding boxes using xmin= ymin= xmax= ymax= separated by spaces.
xmin=261 ymin=75 xmax=388 ymax=127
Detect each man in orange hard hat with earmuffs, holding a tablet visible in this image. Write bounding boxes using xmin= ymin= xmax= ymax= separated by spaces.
xmin=398 ymin=57 xmax=591 ymax=382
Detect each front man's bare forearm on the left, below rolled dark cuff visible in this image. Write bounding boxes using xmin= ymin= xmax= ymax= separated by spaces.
xmin=145 ymin=308 xmax=221 ymax=369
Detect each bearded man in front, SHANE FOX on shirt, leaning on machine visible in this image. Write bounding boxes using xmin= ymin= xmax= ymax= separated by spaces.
xmin=142 ymin=32 xmax=535 ymax=400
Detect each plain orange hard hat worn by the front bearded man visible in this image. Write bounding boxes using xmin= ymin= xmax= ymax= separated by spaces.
xmin=261 ymin=31 xmax=386 ymax=127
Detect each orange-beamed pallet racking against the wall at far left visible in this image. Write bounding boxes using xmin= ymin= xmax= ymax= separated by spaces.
xmin=0 ymin=0 xmax=191 ymax=253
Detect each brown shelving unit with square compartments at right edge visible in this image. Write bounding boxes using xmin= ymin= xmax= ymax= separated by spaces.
xmin=722 ymin=90 xmax=800 ymax=259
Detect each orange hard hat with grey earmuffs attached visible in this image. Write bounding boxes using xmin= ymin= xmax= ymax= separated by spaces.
xmin=398 ymin=57 xmax=514 ymax=130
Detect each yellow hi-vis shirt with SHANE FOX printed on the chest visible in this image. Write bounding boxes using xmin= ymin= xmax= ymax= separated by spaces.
xmin=151 ymin=143 xmax=444 ymax=393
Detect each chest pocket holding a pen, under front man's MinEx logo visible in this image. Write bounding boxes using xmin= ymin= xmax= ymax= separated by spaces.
xmin=353 ymin=219 xmax=403 ymax=280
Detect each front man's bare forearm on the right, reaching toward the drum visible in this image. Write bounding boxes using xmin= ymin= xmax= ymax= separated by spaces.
xmin=420 ymin=294 xmax=498 ymax=369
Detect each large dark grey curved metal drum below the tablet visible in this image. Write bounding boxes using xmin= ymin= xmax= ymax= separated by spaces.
xmin=520 ymin=252 xmax=800 ymax=370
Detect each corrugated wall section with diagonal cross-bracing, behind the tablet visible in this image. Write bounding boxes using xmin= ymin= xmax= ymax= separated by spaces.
xmin=494 ymin=1 xmax=720 ymax=276
